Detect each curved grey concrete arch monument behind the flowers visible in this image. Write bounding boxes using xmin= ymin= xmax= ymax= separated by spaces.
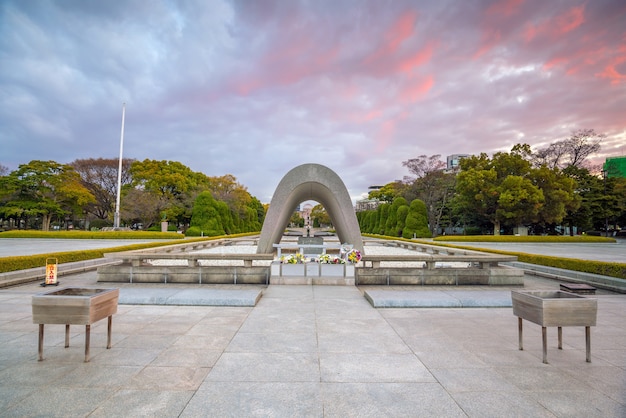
xmin=257 ymin=164 xmax=363 ymax=254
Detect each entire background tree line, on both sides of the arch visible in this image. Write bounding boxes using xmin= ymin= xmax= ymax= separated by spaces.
xmin=0 ymin=129 xmax=626 ymax=238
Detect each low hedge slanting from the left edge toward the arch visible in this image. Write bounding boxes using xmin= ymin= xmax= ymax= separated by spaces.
xmin=0 ymin=233 xmax=257 ymax=273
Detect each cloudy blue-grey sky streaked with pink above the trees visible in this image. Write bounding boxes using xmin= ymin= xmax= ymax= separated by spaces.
xmin=0 ymin=0 xmax=626 ymax=203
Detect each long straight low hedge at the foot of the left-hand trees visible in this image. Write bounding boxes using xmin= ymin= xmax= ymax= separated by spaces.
xmin=0 ymin=229 xmax=185 ymax=239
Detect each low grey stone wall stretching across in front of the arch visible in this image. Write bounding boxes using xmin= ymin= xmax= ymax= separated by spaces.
xmin=98 ymin=241 xmax=524 ymax=286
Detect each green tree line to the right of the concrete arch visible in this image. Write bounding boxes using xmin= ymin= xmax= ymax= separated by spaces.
xmin=357 ymin=129 xmax=626 ymax=237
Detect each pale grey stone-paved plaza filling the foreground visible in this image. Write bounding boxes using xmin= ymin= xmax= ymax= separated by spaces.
xmin=0 ymin=240 xmax=626 ymax=417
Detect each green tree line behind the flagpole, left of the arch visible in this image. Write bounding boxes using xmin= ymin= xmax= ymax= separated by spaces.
xmin=0 ymin=158 xmax=265 ymax=236
